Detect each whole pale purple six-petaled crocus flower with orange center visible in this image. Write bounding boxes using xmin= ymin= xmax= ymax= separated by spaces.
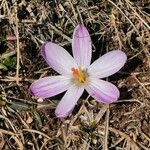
xmin=30 ymin=25 xmax=127 ymax=118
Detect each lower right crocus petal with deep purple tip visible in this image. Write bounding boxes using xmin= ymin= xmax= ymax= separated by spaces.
xmin=85 ymin=77 xmax=120 ymax=104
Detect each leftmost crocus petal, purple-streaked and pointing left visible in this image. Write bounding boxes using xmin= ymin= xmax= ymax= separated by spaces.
xmin=29 ymin=76 xmax=72 ymax=98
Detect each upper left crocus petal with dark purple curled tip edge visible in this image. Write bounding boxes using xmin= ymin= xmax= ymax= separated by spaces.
xmin=41 ymin=42 xmax=77 ymax=75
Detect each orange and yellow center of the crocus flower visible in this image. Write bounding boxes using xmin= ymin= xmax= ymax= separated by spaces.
xmin=71 ymin=68 xmax=87 ymax=84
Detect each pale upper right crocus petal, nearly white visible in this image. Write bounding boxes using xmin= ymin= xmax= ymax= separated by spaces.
xmin=87 ymin=50 xmax=127 ymax=78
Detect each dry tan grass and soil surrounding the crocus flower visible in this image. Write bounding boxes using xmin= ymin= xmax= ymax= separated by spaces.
xmin=0 ymin=0 xmax=150 ymax=150
